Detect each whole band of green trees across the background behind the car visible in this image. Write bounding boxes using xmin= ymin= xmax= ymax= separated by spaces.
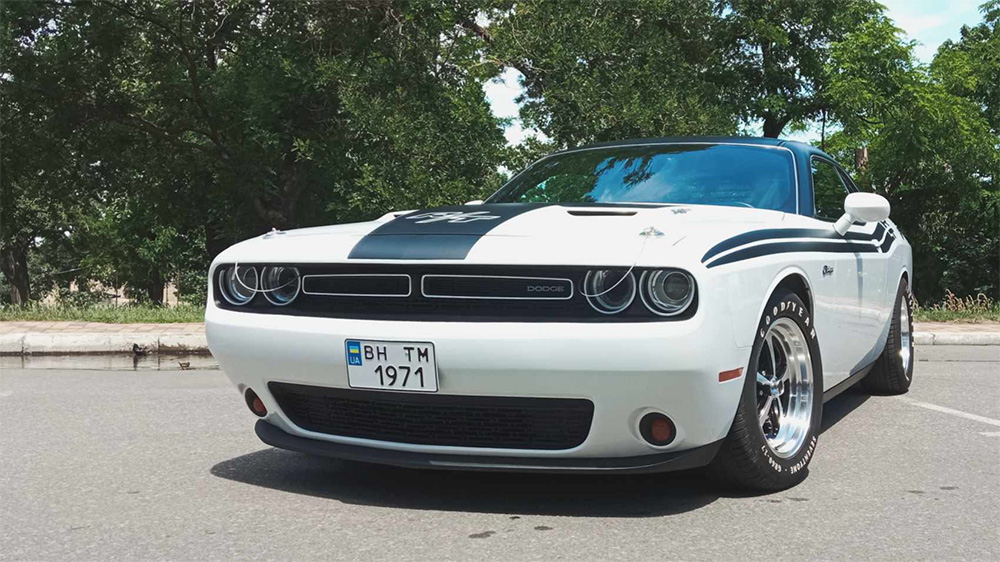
xmin=0 ymin=0 xmax=1000 ymax=314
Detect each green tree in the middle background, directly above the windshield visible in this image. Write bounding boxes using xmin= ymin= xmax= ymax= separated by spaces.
xmin=464 ymin=0 xmax=737 ymax=146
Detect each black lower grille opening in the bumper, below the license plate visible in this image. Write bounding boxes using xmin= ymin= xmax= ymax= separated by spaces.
xmin=268 ymin=382 xmax=594 ymax=449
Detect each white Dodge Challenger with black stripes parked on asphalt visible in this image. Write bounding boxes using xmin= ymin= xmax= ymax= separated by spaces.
xmin=205 ymin=137 xmax=913 ymax=490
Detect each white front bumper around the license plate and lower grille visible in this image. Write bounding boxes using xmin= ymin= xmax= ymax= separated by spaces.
xmin=206 ymin=305 xmax=750 ymax=462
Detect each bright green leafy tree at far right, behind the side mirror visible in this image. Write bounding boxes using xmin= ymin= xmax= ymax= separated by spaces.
xmin=828 ymin=2 xmax=1000 ymax=301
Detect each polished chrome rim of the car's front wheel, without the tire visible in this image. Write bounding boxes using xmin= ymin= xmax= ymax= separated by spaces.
xmin=756 ymin=318 xmax=815 ymax=459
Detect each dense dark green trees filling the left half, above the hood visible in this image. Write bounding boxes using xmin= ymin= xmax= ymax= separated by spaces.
xmin=2 ymin=0 xmax=503 ymax=300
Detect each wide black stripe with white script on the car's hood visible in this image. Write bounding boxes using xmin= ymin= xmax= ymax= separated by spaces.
xmin=348 ymin=203 xmax=547 ymax=260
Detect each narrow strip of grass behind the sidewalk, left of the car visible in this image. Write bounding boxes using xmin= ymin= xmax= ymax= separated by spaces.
xmin=0 ymin=303 xmax=205 ymax=324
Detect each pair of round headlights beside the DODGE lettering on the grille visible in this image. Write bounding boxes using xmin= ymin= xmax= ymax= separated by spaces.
xmin=583 ymin=269 xmax=695 ymax=316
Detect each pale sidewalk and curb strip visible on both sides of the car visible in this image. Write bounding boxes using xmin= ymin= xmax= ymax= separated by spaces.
xmin=0 ymin=322 xmax=1000 ymax=355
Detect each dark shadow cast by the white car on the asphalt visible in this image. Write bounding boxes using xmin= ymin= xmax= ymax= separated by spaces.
xmin=211 ymin=389 xmax=869 ymax=517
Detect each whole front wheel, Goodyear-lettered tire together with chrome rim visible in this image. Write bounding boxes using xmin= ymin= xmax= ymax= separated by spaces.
xmin=710 ymin=291 xmax=823 ymax=491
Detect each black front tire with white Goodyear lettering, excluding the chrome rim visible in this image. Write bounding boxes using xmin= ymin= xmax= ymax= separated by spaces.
xmin=709 ymin=289 xmax=823 ymax=491
